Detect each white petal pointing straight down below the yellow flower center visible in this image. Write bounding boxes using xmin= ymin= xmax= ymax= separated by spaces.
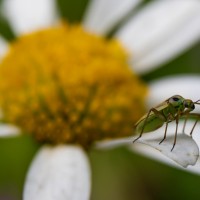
xmin=24 ymin=145 xmax=90 ymax=200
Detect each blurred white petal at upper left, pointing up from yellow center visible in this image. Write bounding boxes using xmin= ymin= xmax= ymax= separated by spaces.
xmin=3 ymin=0 xmax=57 ymax=34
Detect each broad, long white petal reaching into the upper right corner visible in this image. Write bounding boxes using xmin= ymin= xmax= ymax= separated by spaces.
xmin=116 ymin=0 xmax=200 ymax=73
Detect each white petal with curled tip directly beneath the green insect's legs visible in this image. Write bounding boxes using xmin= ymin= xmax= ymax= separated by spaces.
xmin=96 ymin=120 xmax=200 ymax=174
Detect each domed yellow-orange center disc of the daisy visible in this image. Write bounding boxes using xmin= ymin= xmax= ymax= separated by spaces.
xmin=0 ymin=25 xmax=146 ymax=146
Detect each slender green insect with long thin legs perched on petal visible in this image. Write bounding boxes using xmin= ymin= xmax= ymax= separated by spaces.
xmin=133 ymin=95 xmax=200 ymax=151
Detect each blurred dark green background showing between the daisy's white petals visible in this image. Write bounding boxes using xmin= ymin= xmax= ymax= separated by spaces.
xmin=0 ymin=0 xmax=200 ymax=200
